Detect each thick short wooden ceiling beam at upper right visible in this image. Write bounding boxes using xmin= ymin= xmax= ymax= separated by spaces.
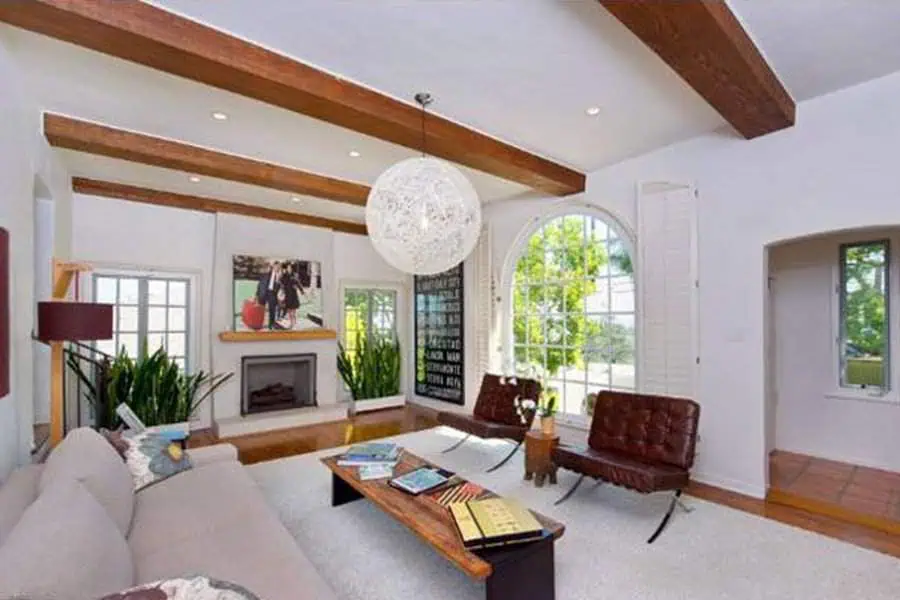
xmin=599 ymin=0 xmax=796 ymax=139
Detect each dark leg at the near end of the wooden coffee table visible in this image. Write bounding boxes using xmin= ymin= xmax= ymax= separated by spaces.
xmin=479 ymin=535 xmax=556 ymax=600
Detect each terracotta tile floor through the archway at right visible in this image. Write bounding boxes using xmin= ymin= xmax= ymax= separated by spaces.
xmin=769 ymin=450 xmax=900 ymax=521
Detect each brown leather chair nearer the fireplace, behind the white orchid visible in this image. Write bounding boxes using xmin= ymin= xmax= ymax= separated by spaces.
xmin=438 ymin=374 xmax=541 ymax=472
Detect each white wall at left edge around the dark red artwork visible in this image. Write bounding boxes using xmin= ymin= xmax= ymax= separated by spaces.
xmin=0 ymin=38 xmax=71 ymax=479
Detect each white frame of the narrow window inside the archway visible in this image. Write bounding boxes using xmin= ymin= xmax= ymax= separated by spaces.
xmin=825 ymin=231 xmax=900 ymax=404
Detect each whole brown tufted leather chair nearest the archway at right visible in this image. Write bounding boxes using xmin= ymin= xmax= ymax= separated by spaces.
xmin=553 ymin=391 xmax=700 ymax=544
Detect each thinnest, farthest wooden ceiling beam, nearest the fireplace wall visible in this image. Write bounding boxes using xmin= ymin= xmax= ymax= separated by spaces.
xmin=72 ymin=177 xmax=366 ymax=235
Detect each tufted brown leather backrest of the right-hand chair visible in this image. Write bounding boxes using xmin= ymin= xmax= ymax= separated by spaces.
xmin=588 ymin=391 xmax=700 ymax=470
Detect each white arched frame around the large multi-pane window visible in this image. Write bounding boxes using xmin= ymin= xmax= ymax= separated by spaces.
xmin=500 ymin=199 xmax=642 ymax=429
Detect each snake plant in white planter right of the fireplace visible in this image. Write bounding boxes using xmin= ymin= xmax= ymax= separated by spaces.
xmin=338 ymin=333 xmax=406 ymax=412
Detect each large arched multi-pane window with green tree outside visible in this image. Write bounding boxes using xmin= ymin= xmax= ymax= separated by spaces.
xmin=512 ymin=214 xmax=636 ymax=415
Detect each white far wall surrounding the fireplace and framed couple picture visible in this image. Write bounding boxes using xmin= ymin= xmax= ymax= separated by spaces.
xmin=73 ymin=194 xmax=405 ymax=426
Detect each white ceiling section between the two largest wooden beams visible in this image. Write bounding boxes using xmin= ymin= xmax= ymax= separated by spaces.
xmin=153 ymin=0 xmax=723 ymax=172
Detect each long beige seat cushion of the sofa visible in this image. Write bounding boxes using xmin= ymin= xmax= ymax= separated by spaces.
xmin=128 ymin=461 xmax=335 ymax=600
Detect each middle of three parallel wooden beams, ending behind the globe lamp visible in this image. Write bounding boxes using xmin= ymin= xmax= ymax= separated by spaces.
xmin=44 ymin=113 xmax=369 ymax=206
